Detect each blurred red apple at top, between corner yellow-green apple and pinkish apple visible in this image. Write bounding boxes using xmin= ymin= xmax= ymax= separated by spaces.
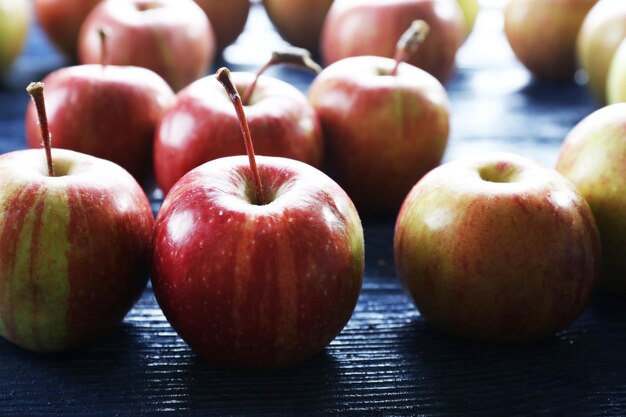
xmin=33 ymin=0 xmax=102 ymax=60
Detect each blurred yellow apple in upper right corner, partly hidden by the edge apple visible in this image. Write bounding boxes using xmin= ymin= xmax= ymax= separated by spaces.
xmin=576 ymin=0 xmax=626 ymax=103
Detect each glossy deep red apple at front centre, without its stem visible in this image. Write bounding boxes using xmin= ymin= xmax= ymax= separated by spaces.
xmin=152 ymin=155 xmax=364 ymax=368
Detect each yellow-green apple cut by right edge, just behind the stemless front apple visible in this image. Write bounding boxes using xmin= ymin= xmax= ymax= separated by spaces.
xmin=556 ymin=103 xmax=626 ymax=296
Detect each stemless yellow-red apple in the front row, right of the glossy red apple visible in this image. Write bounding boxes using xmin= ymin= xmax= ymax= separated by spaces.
xmin=394 ymin=153 xmax=601 ymax=343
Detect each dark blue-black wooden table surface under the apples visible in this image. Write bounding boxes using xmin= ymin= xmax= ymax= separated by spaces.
xmin=0 ymin=1 xmax=626 ymax=417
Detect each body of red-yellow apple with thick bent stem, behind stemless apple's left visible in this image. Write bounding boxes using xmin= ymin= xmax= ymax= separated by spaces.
xmin=309 ymin=56 xmax=449 ymax=214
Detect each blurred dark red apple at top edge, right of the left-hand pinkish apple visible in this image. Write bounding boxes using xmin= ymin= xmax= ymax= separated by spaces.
xmin=195 ymin=0 xmax=250 ymax=51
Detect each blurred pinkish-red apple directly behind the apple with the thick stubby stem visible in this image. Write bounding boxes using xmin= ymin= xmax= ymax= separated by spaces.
xmin=321 ymin=0 xmax=465 ymax=83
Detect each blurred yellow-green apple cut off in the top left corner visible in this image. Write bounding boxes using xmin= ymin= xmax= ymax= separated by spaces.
xmin=0 ymin=0 xmax=31 ymax=74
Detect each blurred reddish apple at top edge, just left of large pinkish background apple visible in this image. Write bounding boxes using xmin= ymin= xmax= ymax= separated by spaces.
xmin=263 ymin=0 xmax=333 ymax=53
